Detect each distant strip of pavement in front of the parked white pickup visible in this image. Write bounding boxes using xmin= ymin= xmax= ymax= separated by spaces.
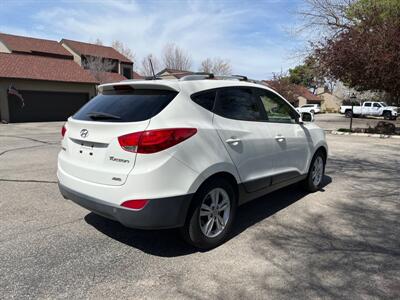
xmin=315 ymin=114 xmax=400 ymax=130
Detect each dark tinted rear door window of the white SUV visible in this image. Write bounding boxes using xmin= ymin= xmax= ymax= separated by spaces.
xmin=216 ymin=88 xmax=262 ymax=121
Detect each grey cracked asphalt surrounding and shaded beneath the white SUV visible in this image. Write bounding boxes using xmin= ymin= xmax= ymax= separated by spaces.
xmin=0 ymin=123 xmax=400 ymax=299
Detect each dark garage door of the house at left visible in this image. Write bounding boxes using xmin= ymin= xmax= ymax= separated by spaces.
xmin=8 ymin=91 xmax=89 ymax=123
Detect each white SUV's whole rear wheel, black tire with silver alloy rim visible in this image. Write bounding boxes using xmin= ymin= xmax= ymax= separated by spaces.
xmin=181 ymin=178 xmax=237 ymax=250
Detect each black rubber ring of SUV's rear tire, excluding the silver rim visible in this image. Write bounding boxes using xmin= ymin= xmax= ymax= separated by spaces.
xmin=183 ymin=179 xmax=237 ymax=249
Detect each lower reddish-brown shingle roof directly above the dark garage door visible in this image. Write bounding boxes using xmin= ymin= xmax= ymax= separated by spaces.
xmin=0 ymin=53 xmax=97 ymax=83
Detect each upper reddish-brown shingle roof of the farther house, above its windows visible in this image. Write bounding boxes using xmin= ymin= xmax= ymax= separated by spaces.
xmin=60 ymin=39 xmax=132 ymax=63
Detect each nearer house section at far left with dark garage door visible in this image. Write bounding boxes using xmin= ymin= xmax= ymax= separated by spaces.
xmin=0 ymin=33 xmax=97 ymax=122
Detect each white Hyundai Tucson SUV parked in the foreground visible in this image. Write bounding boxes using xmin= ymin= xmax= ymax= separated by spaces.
xmin=57 ymin=76 xmax=328 ymax=249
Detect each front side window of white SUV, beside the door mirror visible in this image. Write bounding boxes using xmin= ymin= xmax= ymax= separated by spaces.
xmin=257 ymin=90 xmax=298 ymax=123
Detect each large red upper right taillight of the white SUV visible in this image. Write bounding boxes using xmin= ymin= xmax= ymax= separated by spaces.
xmin=118 ymin=128 xmax=197 ymax=154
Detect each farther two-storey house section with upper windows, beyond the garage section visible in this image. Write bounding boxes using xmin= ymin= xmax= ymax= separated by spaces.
xmin=60 ymin=39 xmax=133 ymax=83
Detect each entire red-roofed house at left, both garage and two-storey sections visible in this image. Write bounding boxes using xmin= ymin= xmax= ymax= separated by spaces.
xmin=0 ymin=33 xmax=141 ymax=122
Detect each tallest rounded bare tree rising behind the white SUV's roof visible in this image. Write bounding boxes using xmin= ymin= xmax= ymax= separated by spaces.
xmin=163 ymin=43 xmax=192 ymax=71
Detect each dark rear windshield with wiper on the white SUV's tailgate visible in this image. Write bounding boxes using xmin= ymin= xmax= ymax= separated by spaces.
xmin=73 ymin=89 xmax=178 ymax=122
